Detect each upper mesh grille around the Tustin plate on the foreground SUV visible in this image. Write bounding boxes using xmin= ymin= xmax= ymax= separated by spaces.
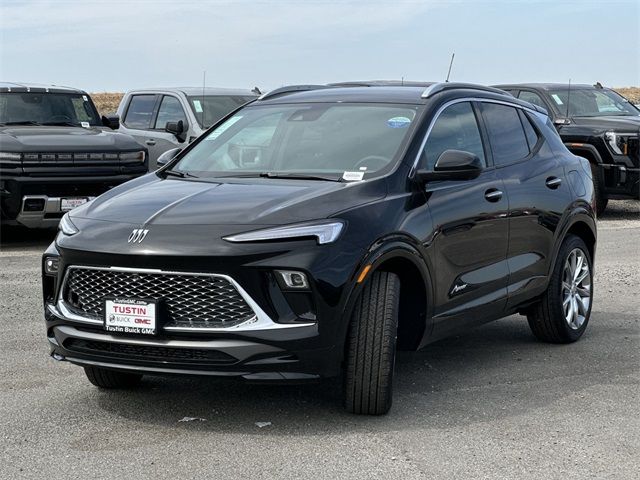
xmin=63 ymin=267 xmax=255 ymax=328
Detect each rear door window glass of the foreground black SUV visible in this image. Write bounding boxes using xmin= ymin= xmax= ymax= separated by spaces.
xmin=482 ymin=102 xmax=529 ymax=166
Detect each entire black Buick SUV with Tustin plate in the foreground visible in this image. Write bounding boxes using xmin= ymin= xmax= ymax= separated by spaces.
xmin=42 ymin=83 xmax=596 ymax=414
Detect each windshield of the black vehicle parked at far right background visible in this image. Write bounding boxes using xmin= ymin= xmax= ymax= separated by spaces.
xmin=549 ymin=88 xmax=640 ymax=117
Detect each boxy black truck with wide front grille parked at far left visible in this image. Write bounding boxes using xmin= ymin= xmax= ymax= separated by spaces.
xmin=0 ymin=83 xmax=148 ymax=227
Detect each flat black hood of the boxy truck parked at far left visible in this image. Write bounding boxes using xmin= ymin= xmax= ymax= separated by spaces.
xmin=0 ymin=126 xmax=143 ymax=152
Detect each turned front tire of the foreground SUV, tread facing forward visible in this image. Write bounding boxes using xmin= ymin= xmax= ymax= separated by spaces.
xmin=344 ymin=272 xmax=400 ymax=415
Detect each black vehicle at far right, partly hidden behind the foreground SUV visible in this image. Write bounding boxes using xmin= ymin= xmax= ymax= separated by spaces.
xmin=498 ymin=83 xmax=640 ymax=214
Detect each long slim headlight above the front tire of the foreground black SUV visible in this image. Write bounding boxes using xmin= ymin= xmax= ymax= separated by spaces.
xmin=224 ymin=220 xmax=344 ymax=245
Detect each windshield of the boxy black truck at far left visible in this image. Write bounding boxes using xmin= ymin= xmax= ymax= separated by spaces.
xmin=0 ymin=92 xmax=101 ymax=127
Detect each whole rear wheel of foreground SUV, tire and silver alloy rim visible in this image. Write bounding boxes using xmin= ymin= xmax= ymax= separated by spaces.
xmin=527 ymin=235 xmax=593 ymax=343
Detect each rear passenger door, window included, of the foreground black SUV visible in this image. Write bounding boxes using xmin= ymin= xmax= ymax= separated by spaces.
xmin=481 ymin=102 xmax=571 ymax=307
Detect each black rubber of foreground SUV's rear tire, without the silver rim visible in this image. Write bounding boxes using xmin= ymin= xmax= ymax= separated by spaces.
xmin=527 ymin=235 xmax=593 ymax=343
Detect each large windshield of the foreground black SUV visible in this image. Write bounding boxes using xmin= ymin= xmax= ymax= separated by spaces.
xmin=173 ymin=103 xmax=418 ymax=180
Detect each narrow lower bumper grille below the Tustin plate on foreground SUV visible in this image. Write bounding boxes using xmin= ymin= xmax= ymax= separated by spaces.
xmin=63 ymin=338 xmax=237 ymax=365
